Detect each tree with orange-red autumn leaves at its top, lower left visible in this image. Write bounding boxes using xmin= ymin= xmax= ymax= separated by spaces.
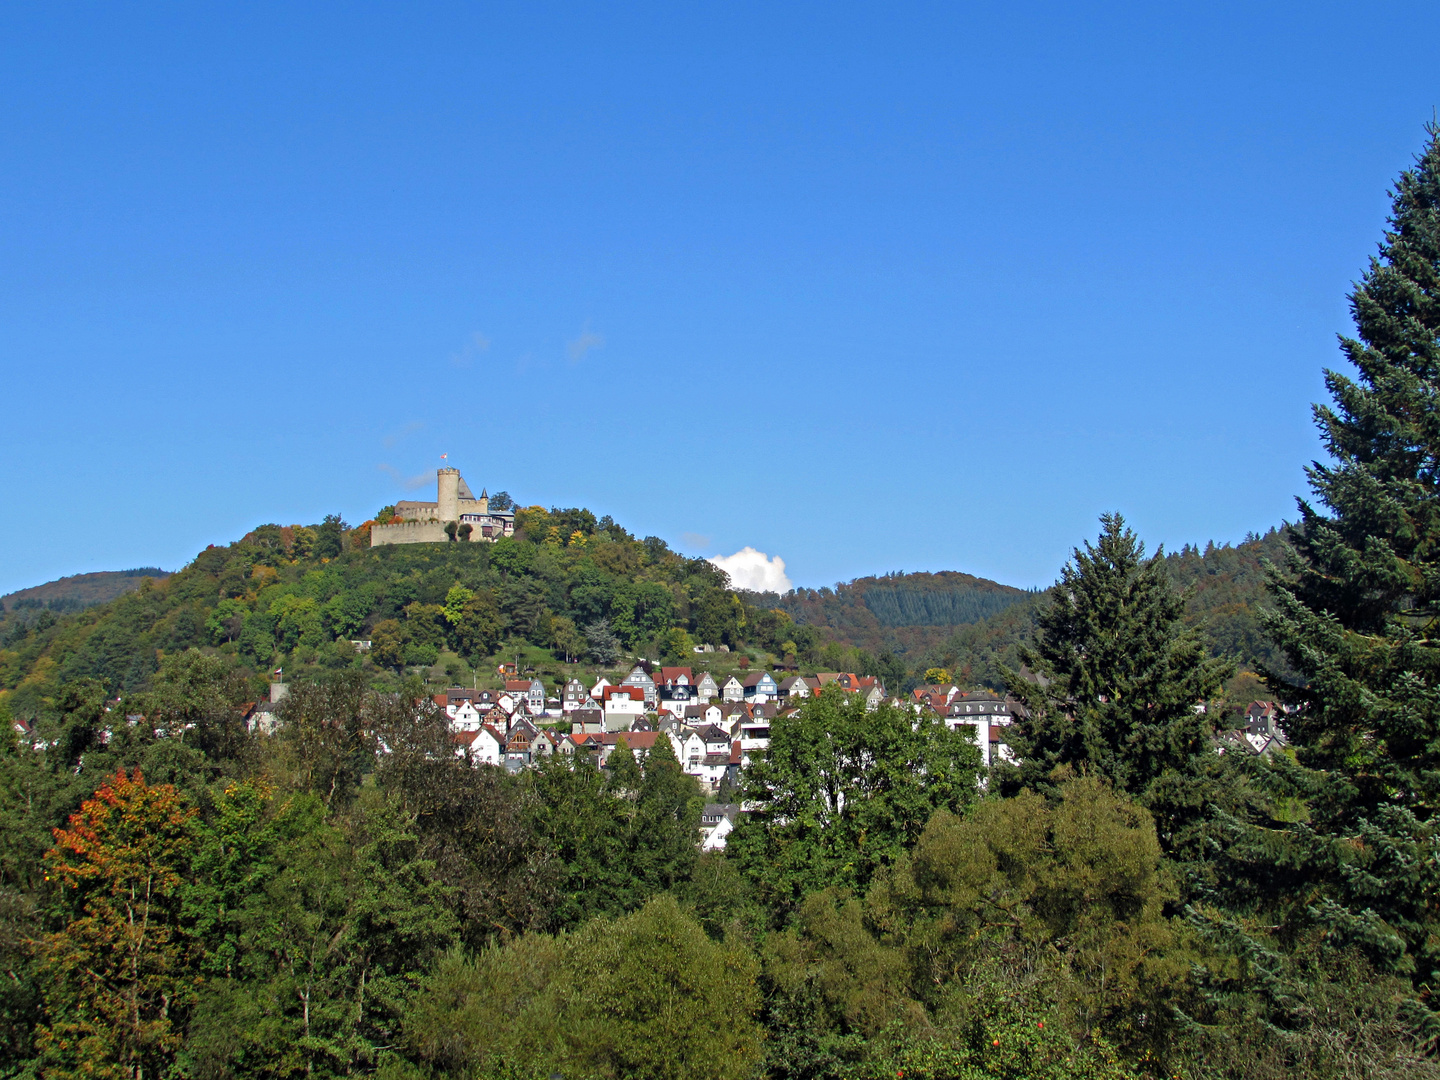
xmin=36 ymin=769 xmax=199 ymax=1080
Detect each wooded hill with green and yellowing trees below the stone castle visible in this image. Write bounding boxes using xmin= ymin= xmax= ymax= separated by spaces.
xmin=0 ymin=507 xmax=800 ymax=719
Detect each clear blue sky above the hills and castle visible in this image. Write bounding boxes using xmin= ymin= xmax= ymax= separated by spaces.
xmin=0 ymin=3 xmax=1440 ymax=592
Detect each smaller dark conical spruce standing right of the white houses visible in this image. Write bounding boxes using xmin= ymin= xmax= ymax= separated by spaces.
xmin=1001 ymin=514 xmax=1231 ymax=852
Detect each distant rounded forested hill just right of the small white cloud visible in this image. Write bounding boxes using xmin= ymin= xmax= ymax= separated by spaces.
xmin=746 ymin=570 xmax=1028 ymax=654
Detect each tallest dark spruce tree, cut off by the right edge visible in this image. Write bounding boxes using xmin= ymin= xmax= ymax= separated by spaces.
xmin=1269 ymin=125 xmax=1440 ymax=985
